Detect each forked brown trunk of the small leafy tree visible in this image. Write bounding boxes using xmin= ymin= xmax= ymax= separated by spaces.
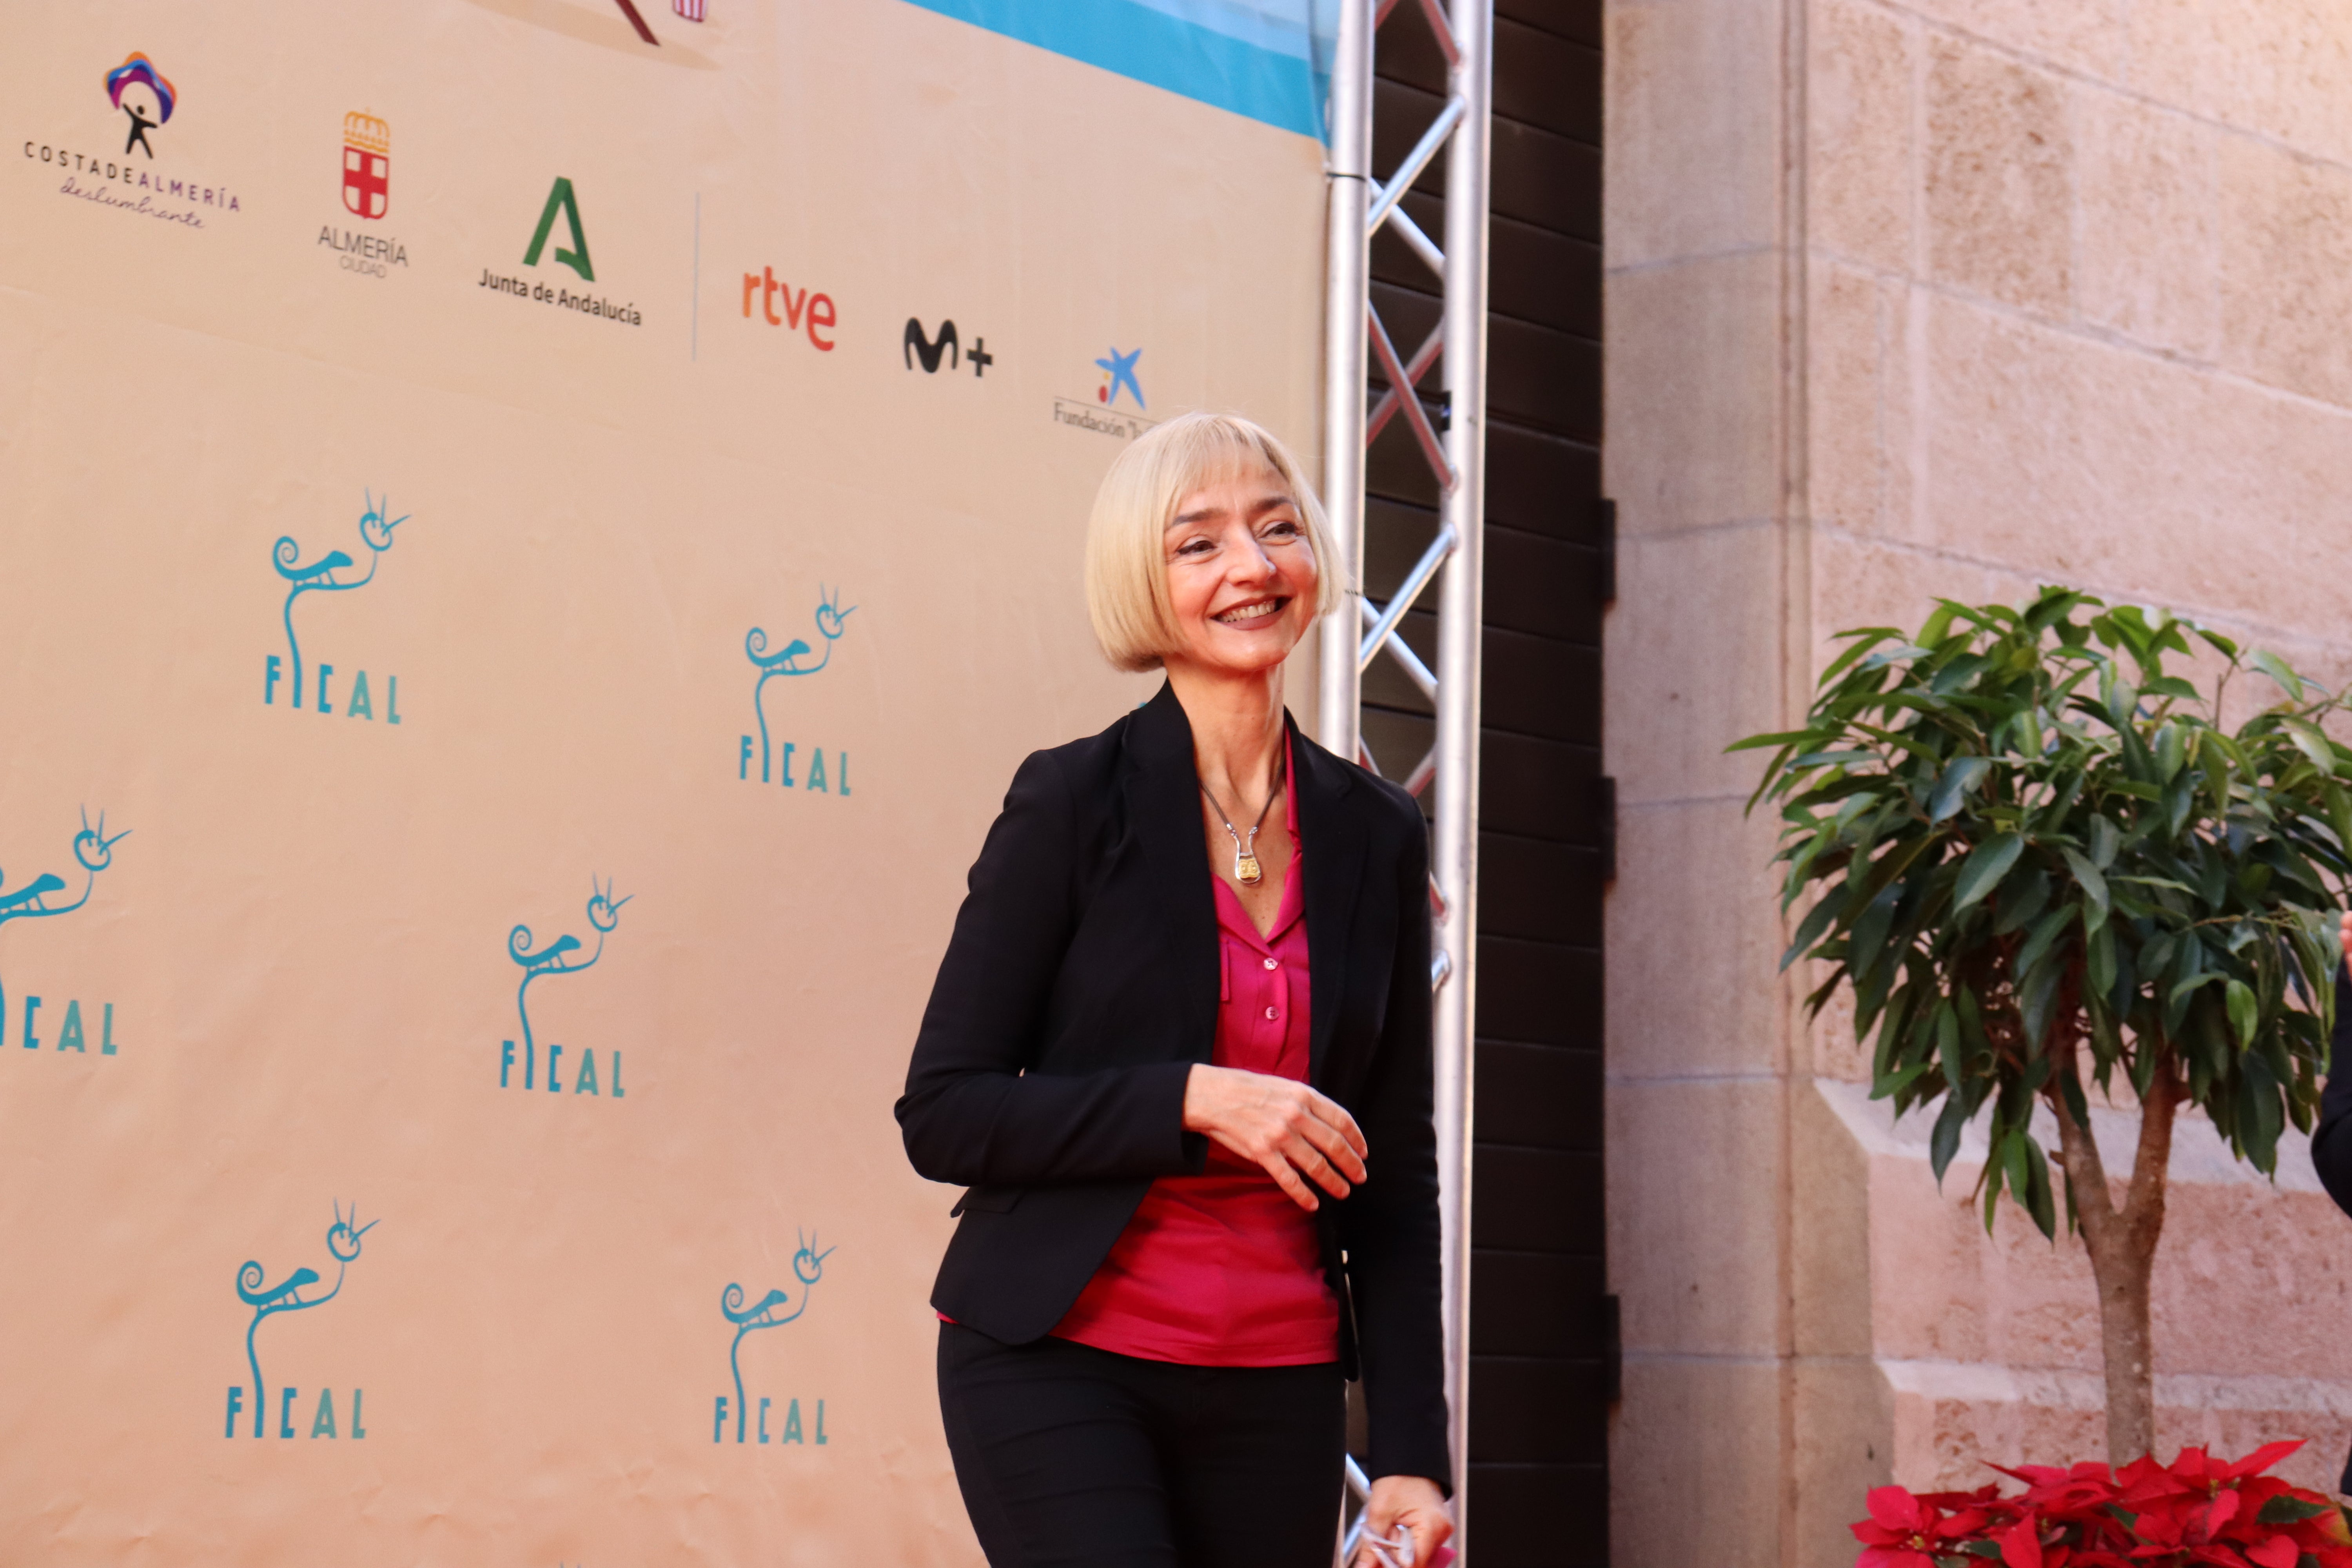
xmin=2049 ymin=1072 xmax=2180 ymax=1465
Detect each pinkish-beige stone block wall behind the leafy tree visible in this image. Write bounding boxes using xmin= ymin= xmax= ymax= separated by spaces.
xmin=1606 ymin=0 xmax=2352 ymax=1568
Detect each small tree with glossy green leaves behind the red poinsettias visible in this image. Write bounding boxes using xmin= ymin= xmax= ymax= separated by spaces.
xmin=1733 ymin=588 xmax=2352 ymax=1465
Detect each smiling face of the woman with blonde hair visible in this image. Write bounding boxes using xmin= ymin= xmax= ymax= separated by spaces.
xmin=1162 ymin=465 xmax=1322 ymax=675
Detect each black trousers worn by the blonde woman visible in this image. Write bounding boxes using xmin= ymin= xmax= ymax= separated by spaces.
xmin=938 ymin=1323 xmax=1348 ymax=1568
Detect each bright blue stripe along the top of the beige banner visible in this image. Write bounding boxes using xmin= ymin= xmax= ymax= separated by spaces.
xmin=908 ymin=0 xmax=1322 ymax=136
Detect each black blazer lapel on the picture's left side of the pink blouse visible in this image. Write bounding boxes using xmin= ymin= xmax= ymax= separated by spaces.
xmin=1122 ymin=684 xmax=1218 ymax=1063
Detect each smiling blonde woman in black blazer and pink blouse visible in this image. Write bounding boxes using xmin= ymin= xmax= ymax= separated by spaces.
xmin=898 ymin=414 xmax=1451 ymax=1568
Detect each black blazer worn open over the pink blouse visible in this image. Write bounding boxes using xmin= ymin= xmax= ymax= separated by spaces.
xmin=898 ymin=686 xmax=1451 ymax=1486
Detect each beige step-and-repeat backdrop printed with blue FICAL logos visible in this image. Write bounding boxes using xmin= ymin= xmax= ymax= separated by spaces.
xmin=0 ymin=0 xmax=1324 ymax=1568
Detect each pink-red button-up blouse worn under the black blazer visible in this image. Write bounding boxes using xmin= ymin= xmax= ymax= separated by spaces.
xmin=1054 ymin=743 xmax=1338 ymax=1366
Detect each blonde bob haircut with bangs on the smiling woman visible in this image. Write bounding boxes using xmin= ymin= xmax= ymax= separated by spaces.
xmin=1087 ymin=414 xmax=1341 ymax=670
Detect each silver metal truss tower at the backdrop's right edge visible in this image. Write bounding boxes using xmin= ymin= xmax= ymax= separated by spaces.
xmin=1319 ymin=0 xmax=1494 ymax=1547
